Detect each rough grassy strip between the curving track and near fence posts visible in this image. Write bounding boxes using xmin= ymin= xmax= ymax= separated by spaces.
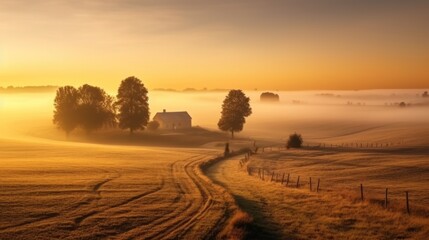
xmin=207 ymin=155 xmax=429 ymax=239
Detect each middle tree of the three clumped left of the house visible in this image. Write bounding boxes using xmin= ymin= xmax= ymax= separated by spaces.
xmin=78 ymin=84 xmax=116 ymax=134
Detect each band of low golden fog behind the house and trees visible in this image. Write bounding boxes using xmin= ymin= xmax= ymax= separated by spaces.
xmin=0 ymin=90 xmax=429 ymax=141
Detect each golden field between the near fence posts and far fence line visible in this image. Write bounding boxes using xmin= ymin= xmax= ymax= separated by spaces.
xmin=249 ymin=146 xmax=429 ymax=217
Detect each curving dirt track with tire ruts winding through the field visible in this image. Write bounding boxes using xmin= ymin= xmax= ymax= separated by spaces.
xmin=119 ymin=155 xmax=231 ymax=239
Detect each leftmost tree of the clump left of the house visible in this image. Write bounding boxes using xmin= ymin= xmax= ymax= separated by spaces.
xmin=53 ymin=86 xmax=79 ymax=137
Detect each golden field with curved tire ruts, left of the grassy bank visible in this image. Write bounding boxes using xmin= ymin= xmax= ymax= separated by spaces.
xmin=0 ymin=141 xmax=234 ymax=239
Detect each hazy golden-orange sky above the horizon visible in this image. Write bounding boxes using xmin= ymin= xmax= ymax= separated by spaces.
xmin=0 ymin=0 xmax=429 ymax=90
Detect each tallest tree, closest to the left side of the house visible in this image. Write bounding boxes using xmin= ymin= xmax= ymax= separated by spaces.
xmin=116 ymin=77 xmax=150 ymax=134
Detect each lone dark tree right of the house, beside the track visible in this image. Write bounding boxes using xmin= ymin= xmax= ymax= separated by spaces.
xmin=218 ymin=90 xmax=252 ymax=138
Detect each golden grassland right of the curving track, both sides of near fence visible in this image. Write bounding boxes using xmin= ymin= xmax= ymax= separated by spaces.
xmin=207 ymin=125 xmax=429 ymax=239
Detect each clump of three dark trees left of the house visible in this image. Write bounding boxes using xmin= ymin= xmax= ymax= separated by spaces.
xmin=53 ymin=77 xmax=150 ymax=136
